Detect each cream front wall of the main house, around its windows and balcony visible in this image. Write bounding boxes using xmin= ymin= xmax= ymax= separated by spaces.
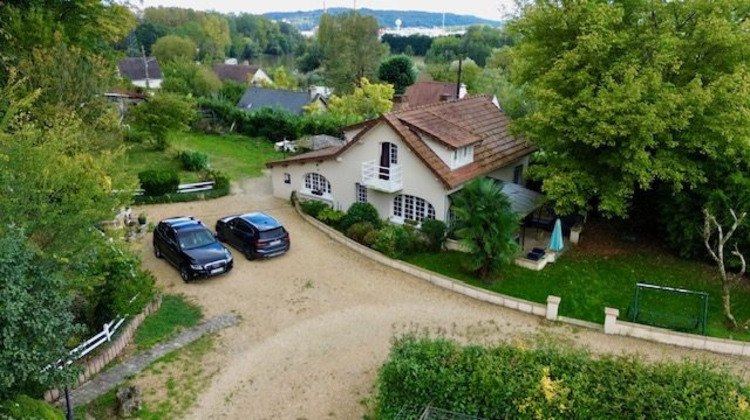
xmin=271 ymin=123 xmax=456 ymax=222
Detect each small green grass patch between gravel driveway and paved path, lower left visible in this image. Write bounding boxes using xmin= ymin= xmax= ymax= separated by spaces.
xmin=134 ymin=295 xmax=203 ymax=350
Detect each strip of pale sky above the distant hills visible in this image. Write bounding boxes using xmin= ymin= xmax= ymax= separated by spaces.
xmin=142 ymin=0 xmax=513 ymax=20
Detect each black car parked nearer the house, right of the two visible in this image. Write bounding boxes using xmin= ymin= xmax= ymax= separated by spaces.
xmin=216 ymin=213 xmax=291 ymax=260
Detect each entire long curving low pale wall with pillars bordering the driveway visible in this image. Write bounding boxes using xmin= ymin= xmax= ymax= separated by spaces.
xmin=294 ymin=204 xmax=750 ymax=356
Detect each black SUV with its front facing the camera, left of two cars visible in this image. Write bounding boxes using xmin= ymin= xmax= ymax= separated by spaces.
xmin=154 ymin=217 xmax=233 ymax=282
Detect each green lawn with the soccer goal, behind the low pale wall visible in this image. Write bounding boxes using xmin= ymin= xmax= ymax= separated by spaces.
xmin=404 ymin=251 xmax=750 ymax=341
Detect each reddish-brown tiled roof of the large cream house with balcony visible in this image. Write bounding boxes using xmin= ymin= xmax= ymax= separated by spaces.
xmin=267 ymin=95 xmax=536 ymax=188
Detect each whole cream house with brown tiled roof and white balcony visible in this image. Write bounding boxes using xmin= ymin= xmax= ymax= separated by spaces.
xmin=268 ymin=95 xmax=536 ymax=223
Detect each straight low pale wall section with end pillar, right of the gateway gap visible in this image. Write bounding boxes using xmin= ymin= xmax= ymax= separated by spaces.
xmin=604 ymin=308 xmax=750 ymax=356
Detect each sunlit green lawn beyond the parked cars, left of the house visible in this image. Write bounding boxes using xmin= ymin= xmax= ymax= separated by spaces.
xmin=126 ymin=132 xmax=284 ymax=183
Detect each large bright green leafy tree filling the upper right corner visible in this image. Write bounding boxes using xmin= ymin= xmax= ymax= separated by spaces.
xmin=510 ymin=0 xmax=750 ymax=217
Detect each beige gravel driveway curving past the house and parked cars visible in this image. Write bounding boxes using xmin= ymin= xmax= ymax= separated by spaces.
xmin=135 ymin=177 xmax=750 ymax=419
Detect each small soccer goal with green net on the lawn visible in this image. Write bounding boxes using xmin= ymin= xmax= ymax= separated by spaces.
xmin=627 ymin=283 xmax=708 ymax=335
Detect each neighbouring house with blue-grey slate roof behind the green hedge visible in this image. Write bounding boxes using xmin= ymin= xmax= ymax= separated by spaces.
xmin=237 ymin=86 xmax=328 ymax=115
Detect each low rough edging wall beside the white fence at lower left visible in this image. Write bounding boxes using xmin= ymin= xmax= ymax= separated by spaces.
xmin=44 ymin=295 xmax=161 ymax=402
